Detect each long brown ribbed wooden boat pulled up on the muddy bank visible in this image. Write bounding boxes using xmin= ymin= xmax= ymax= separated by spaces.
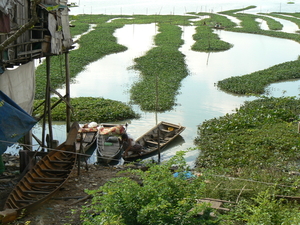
xmin=0 ymin=123 xmax=79 ymax=223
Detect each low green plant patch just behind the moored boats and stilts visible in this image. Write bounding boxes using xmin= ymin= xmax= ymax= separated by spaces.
xmin=33 ymin=97 xmax=139 ymax=123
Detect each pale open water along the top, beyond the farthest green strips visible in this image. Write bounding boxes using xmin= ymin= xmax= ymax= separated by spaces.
xmin=70 ymin=0 xmax=300 ymax=15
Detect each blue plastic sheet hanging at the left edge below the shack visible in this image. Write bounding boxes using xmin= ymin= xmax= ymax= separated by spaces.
xmin=0 ymin=91 xmax=37 ymax=155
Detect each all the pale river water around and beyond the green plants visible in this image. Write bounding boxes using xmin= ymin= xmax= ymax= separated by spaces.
xmin=7 ymin=0 xmax=300 ymax=165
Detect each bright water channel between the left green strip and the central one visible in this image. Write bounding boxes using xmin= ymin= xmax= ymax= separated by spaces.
xmin=58 ymin=23 xmax=157 ymax=102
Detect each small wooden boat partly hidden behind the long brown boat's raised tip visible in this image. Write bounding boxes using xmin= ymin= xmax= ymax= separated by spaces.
xmin=76 ymin=124 xmax=98 ymax=153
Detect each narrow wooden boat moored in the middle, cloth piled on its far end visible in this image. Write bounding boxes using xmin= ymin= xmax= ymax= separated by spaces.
xmin=97 ymin=123 xmax=127 ymax=164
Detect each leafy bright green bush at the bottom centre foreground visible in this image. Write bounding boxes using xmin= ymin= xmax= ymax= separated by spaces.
xmin=81 ymin=152 xmax=218 ymax=225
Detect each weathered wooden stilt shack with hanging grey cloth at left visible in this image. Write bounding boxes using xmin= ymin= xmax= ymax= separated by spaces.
xmin=0 ymin=0 xmax=74 ymax=164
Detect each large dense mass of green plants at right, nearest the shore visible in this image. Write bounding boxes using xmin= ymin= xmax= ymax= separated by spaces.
xmin=196 ymin=97 xmax=300 ymax=173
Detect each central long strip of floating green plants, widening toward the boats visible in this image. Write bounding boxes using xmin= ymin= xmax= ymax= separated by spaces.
xmin=130 ymin=24 xmax=188 ymax=111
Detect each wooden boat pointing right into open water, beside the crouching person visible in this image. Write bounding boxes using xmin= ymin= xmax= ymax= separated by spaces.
xmin=125 ymin=121 xmax=185 ymax=161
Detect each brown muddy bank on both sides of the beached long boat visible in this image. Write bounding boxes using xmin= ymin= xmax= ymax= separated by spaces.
xmin=0 ymin=156 xmax=138 ymax=225
